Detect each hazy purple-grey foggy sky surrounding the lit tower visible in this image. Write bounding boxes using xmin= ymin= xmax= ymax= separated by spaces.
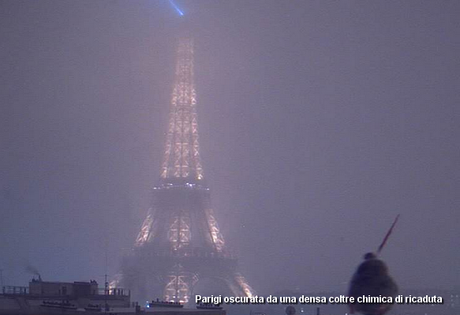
xmin=0 ymin=0 xmax=460 ymax=294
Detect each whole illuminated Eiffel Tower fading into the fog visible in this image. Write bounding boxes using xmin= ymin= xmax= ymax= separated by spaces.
xmin=116 ymin=38 xmax=254 ymax=303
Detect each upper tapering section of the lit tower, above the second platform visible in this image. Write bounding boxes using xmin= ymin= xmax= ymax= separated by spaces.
xmin=161 ymin=37 xmax=203 ymax=180
